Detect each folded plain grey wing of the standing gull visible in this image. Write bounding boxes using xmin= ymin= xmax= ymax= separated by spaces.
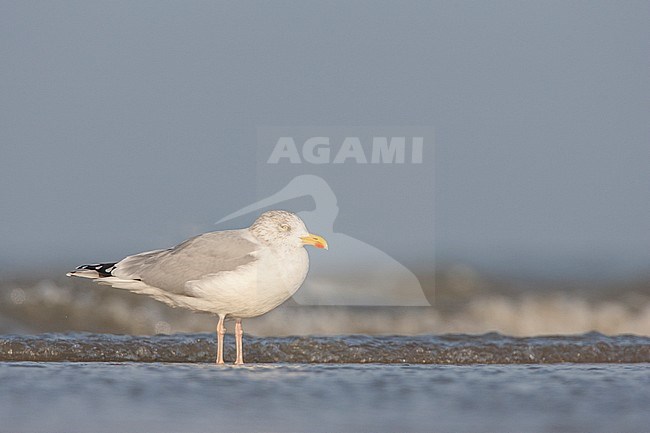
xmin=112 ymin=229 xmax=259 ymax=294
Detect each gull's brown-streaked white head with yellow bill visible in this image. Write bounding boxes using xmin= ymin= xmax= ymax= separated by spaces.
xmin=250 ymin=210 xmax=327 ymax=249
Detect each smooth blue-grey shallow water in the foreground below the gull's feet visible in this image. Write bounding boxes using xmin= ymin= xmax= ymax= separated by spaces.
xmin=0 ymin=362 xmax=650 ymax=433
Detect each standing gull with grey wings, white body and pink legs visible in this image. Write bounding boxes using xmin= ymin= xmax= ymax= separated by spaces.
xmin=67 ymin=210 xmax=328 ymax=365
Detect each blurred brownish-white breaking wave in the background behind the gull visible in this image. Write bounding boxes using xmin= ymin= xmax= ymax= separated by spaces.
xmin=0 ymin=280 xmax=650 ymax=336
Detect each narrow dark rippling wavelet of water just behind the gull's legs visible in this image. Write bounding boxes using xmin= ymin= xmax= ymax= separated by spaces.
xmin=0 ymin=332 xmax=650 ymax=364
